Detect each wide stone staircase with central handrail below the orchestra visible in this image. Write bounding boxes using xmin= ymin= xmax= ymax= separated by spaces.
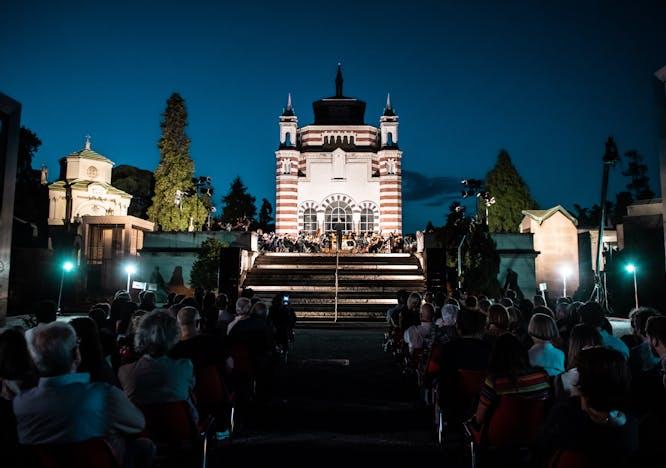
xmin=243 ymin=252 xmax=426 ymax=321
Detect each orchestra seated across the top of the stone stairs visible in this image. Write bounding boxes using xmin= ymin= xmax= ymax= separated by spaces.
xmin=258 ymin=232 xmax=416 ymax=253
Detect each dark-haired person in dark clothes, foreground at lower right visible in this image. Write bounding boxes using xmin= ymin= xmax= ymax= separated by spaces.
xmin=539 ymin=346 xmax=638 ymax=467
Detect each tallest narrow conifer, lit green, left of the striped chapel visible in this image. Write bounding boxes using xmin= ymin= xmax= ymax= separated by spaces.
xmin=148 ymin=93 xmax=208 ymax=231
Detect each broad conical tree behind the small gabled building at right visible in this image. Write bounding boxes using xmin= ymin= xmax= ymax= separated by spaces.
xmin=485 ymin=150 xmax=537 ymax=232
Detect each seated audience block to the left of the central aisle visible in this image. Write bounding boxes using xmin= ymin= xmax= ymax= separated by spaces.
xmin=0 ymin=289 xmax=296 ymax=467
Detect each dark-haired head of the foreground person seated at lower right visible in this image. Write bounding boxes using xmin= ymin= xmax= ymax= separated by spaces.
xmin=576 ymin=346 xmax=629 ymax=413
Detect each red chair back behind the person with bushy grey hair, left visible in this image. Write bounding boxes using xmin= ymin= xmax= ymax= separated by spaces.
xmin=141 ymin=401 xmax=197 ymax=444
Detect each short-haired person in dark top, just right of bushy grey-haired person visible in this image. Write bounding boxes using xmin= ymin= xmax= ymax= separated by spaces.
xmin=169 ymin=307 xmax=224 ymax=370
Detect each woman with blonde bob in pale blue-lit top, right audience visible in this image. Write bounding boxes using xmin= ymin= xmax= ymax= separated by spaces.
xmin=527 ymin=313 xmax=564 ymax=376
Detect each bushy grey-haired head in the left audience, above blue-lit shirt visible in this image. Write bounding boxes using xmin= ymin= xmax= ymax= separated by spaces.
xmin=134 ymin=310 xmax=179 ymax=357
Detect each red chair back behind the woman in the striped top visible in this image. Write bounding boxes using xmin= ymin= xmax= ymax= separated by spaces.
xmin=485 ymin=395 xmax=546 ymax=447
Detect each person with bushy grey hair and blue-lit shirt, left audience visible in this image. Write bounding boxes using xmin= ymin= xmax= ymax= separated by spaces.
xmin=118 ymin=310 xmax=197 ymax=422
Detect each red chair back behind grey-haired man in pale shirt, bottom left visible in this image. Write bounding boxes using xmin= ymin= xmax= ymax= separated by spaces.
xmin=25 ymin=439 xmax=119 ymax=468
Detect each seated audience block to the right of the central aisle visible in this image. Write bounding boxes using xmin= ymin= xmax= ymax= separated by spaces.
xmin=385 ymin=290 xmax=666 ymax=467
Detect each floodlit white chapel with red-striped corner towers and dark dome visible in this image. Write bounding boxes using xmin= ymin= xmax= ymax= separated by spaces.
xmin=275 ymin=65 xmax=402 ymax=235
